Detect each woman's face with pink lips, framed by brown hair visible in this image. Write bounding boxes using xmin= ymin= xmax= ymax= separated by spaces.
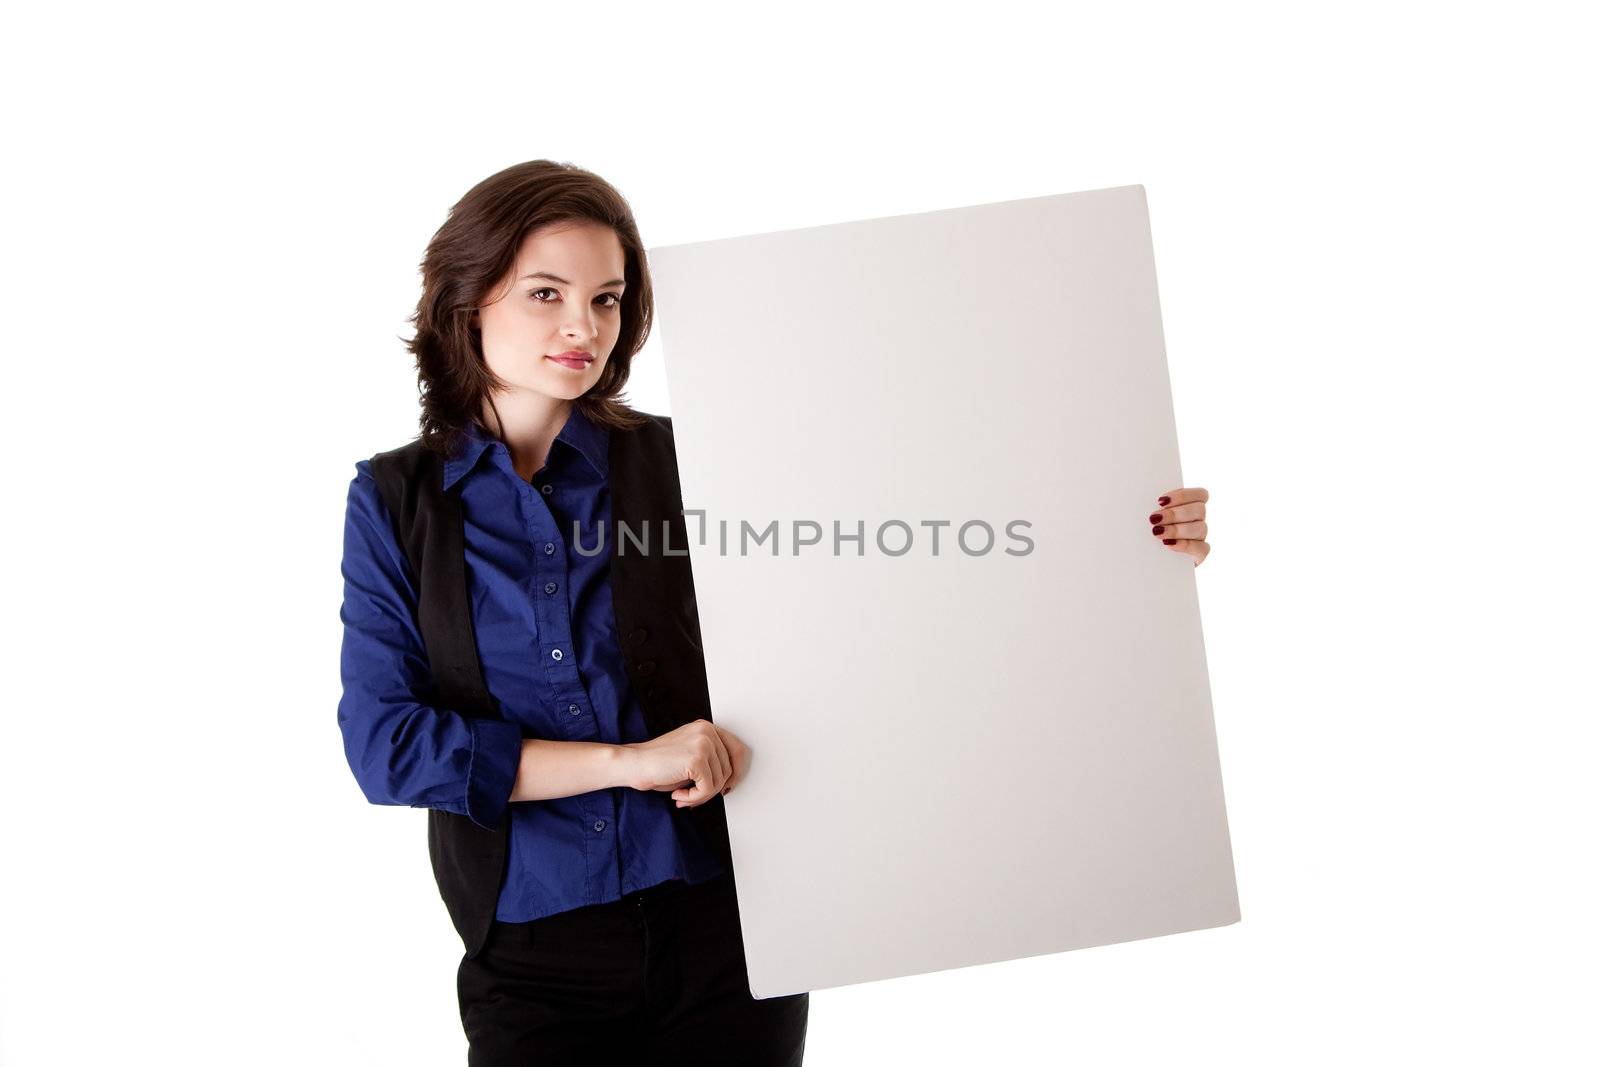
xmin=478 ymin=221 xmax=624 ymax=400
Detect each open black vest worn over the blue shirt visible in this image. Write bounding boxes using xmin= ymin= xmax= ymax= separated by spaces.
xmin=371 ymin=414 xmax=733 ymax=957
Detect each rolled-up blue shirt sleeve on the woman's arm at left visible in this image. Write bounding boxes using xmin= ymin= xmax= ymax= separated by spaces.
xmin=339 ymin=459 xmax=522 ymax=829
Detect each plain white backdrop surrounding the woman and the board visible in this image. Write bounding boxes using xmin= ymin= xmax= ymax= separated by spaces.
xmin=0 ymin=3 xmax=1600 ymax=1067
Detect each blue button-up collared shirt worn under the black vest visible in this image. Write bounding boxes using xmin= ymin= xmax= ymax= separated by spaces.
xmin=339 ymin=406 xmax=723 ymax=923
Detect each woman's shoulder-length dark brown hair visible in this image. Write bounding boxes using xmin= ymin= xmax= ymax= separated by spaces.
xmin=402 ymin=160 xmax=654 ymax=456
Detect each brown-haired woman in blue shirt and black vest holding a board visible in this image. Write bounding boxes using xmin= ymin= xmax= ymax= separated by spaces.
xmin=339 ymin=160 xmax=1208 ymax=1065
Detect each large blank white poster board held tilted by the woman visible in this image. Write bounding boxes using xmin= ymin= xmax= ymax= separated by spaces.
xmin=650 ymin=186 xmax=1238 ymax=998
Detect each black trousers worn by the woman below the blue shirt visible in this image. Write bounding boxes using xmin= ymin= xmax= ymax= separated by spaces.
xmin=456 ymin=873 xmax=811 ymax=1067
